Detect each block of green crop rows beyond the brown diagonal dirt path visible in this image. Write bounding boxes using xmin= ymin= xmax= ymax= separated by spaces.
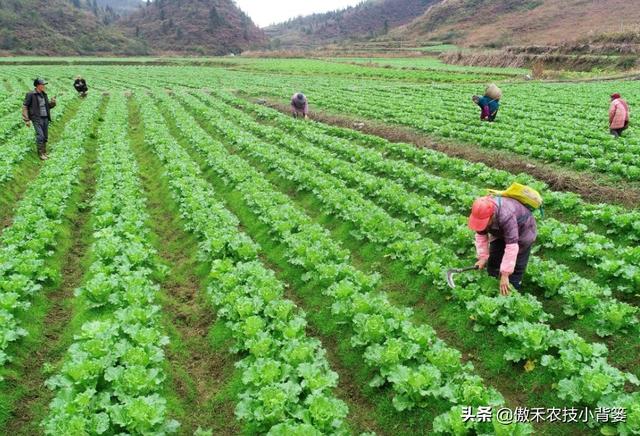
xmin=202 ymin=72 xmax=640 ymax=180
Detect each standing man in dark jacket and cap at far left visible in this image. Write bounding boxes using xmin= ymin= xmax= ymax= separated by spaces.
xmin=22 ymin=79 xmax=56 ymax=160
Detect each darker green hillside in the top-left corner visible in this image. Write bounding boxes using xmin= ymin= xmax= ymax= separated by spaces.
xmin=0 ymin=0 xmax=147 ymax=55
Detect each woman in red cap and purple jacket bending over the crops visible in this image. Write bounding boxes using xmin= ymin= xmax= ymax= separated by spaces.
xmin=469 ymin=196 xmax=538 ymax=295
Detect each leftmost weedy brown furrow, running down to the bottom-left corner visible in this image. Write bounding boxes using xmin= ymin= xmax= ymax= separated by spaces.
xmin=0 ymin=97 xmax=108 ymax=436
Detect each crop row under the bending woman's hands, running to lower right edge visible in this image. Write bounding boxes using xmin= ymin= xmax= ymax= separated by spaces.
xmin=174 ymin=93 xmax=640 ymax=436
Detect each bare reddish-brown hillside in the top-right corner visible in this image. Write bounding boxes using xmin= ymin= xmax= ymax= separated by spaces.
xmin=390 ymin=0 xmax=640 ymax=47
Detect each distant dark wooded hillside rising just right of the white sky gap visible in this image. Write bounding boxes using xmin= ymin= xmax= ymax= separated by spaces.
xmin=265 ymin=0 xmax=438 ymax=49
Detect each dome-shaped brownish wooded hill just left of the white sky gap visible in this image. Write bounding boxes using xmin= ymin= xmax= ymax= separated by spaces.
xmin=119 ymin=0 xmax=267 ymax=55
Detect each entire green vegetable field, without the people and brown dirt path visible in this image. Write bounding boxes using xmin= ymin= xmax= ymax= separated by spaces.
xmin=0 ymin=59 xmax=640 ymax=436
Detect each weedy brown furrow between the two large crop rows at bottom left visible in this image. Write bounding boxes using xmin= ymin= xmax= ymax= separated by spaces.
xmin=129 ymin=97 xmax=241 ymax=435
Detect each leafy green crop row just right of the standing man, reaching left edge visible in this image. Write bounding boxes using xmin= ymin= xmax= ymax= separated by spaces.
xmin=0 ymin=98 xmax=100 ymax=378
